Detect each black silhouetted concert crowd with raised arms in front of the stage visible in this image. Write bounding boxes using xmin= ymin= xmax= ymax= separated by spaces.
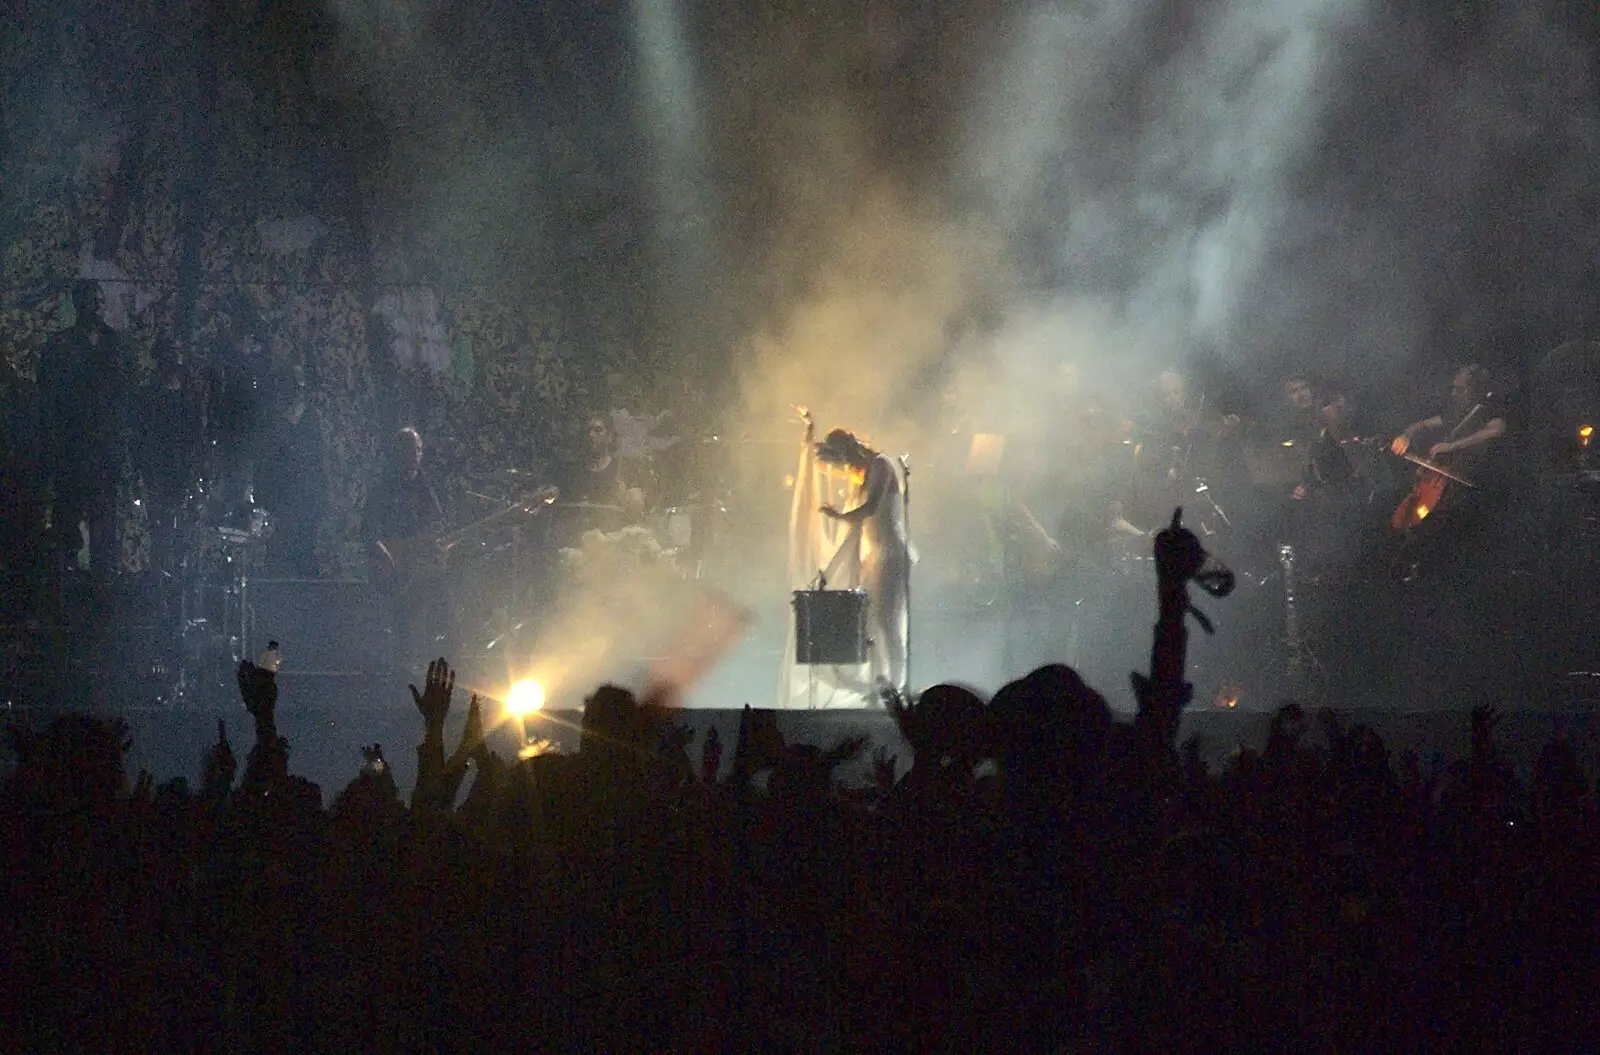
xmin=0 ymin=517 xmax=1600 ymax=1055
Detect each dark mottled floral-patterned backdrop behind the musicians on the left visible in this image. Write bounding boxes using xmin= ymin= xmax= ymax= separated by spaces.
xmin=0 ymin=6 xmax=664 ymax=575
